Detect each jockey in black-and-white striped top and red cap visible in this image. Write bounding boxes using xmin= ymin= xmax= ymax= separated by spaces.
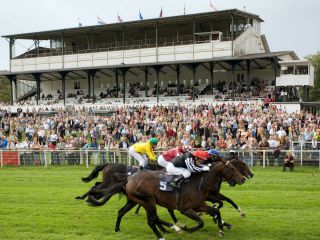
xmin=166 ymin=150 xmax=210 ymax=187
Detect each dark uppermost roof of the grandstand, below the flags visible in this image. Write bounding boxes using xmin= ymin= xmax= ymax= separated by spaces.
xmin=2 ymin=9 xmax=263 ymax=40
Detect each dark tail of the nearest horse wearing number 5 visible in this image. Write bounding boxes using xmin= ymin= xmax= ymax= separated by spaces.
xmin=87 ymin=174 xmax=128 ymax=206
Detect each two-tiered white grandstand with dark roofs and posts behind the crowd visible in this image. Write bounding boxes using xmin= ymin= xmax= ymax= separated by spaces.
xmin=2 ymin=9 xmax=314 ymax=110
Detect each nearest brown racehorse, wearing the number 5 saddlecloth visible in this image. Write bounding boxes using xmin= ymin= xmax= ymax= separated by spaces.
xmin=115 ymin=162 xmax=245 ymax=239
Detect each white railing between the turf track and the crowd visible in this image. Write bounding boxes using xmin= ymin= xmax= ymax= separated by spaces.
xmin=0 ymin=149 xmax=320 ymax=169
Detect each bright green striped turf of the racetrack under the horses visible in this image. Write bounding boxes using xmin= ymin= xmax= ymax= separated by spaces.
xmin=0 ymin=166 xmax=320 ymax=240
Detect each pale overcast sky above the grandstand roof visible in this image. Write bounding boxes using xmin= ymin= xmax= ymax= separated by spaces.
xmin=0 ymin=0 xmax=320 ymax=70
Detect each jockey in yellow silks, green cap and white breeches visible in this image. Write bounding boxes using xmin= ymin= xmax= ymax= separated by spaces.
xmin=129 ymin=138 xmax=158 ymax=170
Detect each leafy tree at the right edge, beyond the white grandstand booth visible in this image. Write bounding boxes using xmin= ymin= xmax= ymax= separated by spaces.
xmin=306 ymin=51 xmax=320 ymax=101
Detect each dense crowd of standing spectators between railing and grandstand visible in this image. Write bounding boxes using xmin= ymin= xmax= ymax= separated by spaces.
xmin=0 ymin=103 xmax=320 ymax=159
